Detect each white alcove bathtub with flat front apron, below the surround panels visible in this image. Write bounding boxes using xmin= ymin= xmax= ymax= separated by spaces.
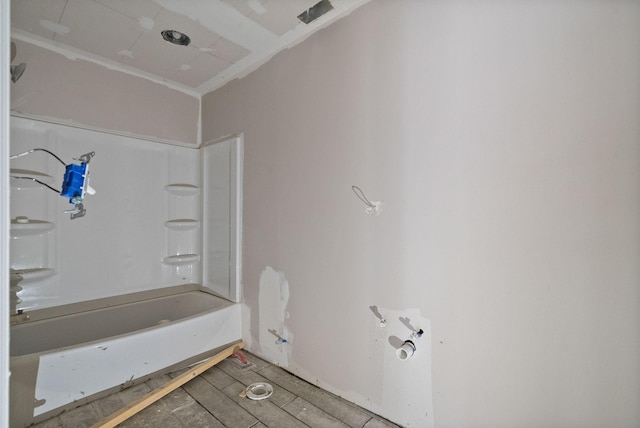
xmin=9 ymin=284 xmax=241 ymax=428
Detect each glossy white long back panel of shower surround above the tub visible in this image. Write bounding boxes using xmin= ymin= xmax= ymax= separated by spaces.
xmin=11 ymin=117 xmax=201 ymax=310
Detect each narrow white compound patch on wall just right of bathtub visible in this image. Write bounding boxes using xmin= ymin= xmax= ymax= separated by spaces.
xmin=258 ymin=266 xmax=293 ymax=367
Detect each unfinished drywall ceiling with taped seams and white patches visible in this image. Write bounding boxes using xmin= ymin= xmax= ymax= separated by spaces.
xmin=11 ymin=0 xmax=369 ymax=96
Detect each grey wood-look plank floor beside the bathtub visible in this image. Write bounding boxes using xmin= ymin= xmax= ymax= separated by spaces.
xmin=34 ymin=353 xmax=399 ymax=428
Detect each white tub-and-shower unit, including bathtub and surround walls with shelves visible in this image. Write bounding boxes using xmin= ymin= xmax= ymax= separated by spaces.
xmin=10 ymin=117 xmax=242 ymax=426
